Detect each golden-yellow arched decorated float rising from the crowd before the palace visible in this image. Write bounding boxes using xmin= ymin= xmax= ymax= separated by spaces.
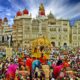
xmin=31 ymin=37 xmax=50 ymax=58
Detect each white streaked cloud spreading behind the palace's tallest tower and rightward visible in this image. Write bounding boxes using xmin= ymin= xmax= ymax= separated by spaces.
xmin=23 ymin=0 xmax=80 ymax=19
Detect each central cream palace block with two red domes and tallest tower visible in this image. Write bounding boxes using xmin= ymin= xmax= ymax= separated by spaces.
xmin=12 ymin=4 xmax=71 ymax=48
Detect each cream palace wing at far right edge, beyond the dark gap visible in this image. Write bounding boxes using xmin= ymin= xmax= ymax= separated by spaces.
xmin=71 ymin=20 xmax=80 ymax=47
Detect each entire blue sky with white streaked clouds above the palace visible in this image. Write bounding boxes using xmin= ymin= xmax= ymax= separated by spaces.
xmin=0 ymin=0 xmax=80 ymax=25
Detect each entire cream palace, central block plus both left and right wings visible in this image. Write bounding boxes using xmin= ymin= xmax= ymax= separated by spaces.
xmin=0 ymin=4 xmax=80 ymax=48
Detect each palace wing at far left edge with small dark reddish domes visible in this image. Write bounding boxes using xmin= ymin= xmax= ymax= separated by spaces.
xmin=0 ymin=17 xmax=12 ymax=47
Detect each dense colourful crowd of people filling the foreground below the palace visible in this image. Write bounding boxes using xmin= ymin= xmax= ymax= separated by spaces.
xmin=0 ymin=46 xmax=80 ymax=80
